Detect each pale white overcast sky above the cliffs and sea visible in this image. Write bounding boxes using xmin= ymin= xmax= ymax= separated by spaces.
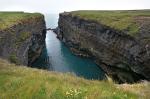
xmin=0 ymin=0 xmax=150 ymax=13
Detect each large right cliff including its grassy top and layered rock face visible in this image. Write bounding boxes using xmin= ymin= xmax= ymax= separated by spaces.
xmin=57 ymin=10 xmax=150 ymax=83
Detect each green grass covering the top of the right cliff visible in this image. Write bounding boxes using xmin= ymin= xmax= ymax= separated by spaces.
xmin=71 ymin=10 xmax=150 ymax=36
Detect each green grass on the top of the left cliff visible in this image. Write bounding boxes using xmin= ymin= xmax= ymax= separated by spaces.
xmin=0 ymin=12 xmax=41 ymax=30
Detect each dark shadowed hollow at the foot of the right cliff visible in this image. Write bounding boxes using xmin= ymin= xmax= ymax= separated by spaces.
xmin=101 ymin=64 xmax=146 ymax=84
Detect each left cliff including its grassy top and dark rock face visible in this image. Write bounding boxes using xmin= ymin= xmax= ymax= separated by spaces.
xmin=0 ymin=12 xmax=46 ymax=65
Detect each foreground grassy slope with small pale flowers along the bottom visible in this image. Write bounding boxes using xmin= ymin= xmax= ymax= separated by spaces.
xmin=0 ymin=60 xmax=150 ymax=99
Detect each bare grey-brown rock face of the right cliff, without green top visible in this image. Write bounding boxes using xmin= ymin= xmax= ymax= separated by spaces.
xmin=57 ymin=10 xmax=150 ymax=83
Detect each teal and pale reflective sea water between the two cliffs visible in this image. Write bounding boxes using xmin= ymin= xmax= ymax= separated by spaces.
xmin=33 ymin=14 xmax=105 ymax=80
